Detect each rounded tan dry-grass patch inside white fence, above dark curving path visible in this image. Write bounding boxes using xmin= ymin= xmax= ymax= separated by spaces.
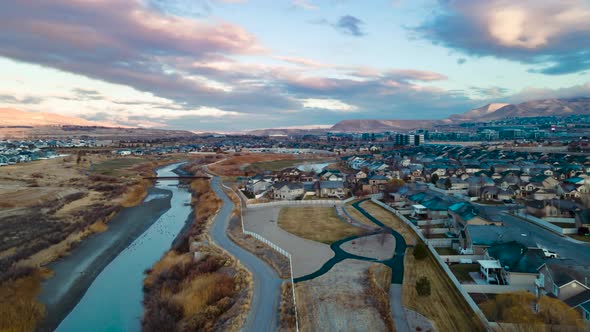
xmin=279 ymin=206 xmax=364 ymax=244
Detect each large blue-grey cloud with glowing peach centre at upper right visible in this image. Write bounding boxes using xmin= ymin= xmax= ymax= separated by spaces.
xmin=413 ymin=0 xmax=590 ymax=75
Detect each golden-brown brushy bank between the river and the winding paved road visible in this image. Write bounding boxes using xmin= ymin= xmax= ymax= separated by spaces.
xmin=142 ymin=170 xmax=252 ymax=331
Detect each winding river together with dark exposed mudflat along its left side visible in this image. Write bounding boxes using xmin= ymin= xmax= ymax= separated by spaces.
xmin=40 ymin=164 xmax=192 ymax=331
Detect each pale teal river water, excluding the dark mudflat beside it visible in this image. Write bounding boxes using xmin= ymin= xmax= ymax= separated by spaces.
xmin=57 ymin=164 xmax=192 ymax=332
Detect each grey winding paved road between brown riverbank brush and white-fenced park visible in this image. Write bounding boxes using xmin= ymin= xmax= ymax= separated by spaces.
xmin=210 ymin=176 xmax=282 ymax=332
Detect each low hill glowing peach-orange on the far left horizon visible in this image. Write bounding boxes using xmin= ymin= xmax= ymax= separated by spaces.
xmin=0 ymin=108 xmax=123 ymax=128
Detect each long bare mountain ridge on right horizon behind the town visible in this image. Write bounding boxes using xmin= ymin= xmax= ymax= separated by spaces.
xmin=327 ymin=97 xmax=590 ymax=132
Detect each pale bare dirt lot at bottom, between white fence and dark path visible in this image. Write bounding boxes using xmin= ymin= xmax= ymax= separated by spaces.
xmin=295 ymin=259 xmax=386 ymax=331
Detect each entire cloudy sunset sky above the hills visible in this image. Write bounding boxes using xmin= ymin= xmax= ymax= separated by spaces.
xmin=0 ymin=0 xmax=590 ymax=131
